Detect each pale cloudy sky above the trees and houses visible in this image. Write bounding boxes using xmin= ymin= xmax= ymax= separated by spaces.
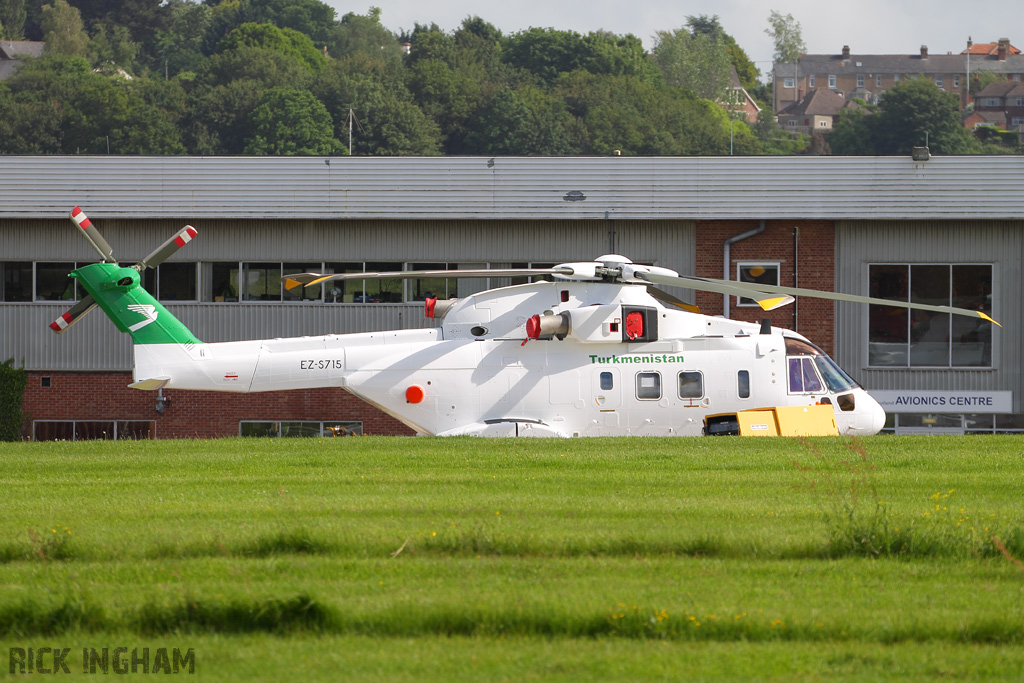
xmin=323 ymin=0 xmax=1007 ymax=80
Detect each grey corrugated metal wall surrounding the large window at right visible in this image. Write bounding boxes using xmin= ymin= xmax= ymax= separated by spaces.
xmin=836 ymin=220 xmax=1024 ymax=411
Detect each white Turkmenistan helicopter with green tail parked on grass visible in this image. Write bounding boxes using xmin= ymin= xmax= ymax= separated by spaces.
xmin=51 ymin=207 xmax=994 ymax=437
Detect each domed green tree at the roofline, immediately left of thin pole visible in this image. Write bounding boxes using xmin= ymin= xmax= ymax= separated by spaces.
xmin=245 ymin=88 xmax=347 ymax=156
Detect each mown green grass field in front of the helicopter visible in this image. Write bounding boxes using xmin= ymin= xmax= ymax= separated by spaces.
xmin=0 ymin=436 xmax=1024 ymax=681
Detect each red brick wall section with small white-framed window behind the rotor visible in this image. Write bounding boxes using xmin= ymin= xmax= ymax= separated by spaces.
xmin=696 ymin=220 xmax=836 ymax=355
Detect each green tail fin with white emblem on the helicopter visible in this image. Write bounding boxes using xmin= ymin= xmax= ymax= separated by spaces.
xmin=71 ymin=263 xmax=200 ymax=344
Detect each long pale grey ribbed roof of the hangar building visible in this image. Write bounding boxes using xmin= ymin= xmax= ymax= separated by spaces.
xmin=0 ymin=156 xmax=1024 ymax=221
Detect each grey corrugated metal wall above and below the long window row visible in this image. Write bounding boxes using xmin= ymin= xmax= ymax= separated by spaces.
xmin=0 ymin=218 xmax=696 ymax=371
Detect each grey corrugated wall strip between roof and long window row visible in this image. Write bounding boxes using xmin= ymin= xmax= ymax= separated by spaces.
xmin=0 ymin=218 xmax=694 ymax=269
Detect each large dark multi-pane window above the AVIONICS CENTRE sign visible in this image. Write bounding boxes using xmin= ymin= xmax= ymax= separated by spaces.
xmin=867 ymin=263 xmax=993 ymax=368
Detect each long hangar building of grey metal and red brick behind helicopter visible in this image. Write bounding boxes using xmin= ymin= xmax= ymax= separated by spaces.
xmin=0 ymin=155 xmax=1024 ymax=439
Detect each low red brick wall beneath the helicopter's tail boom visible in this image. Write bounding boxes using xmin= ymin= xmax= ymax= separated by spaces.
xmin=22 ymin=372 xmax=413 ymax=438
